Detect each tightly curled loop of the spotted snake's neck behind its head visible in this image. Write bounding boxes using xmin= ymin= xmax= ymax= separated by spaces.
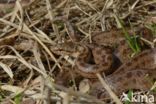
xmin=75 ymin=44 xmax=113 ymax=78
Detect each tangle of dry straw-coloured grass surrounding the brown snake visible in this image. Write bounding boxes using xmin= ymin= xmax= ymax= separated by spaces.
xmin=0 ymin=0 xmax=156 ymax=104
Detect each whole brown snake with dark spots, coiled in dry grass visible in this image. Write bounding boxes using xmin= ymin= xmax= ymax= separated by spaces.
xmin=52 ymin=29 xmax=156 ymax=99
